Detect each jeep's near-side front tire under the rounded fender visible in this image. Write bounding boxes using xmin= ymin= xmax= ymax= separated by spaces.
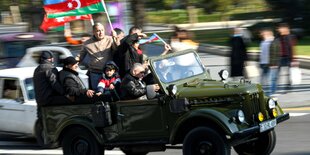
xmin=183 ymin=127 xmax=230 ymax=155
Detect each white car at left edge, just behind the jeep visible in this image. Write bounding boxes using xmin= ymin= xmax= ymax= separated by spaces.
xmin=0 ymin=67 xmax=37 ymax=137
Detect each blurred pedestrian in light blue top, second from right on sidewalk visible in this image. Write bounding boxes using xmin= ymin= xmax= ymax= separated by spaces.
xmin=259 ymin=29 xmax=274 ymax=86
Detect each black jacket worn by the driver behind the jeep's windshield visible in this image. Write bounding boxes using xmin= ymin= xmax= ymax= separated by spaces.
xmin=121 ymin=73 xmax=146 ymax=100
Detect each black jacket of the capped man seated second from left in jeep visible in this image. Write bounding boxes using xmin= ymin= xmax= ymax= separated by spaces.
xmin=59 ymin=68 xmax=87 ymax=97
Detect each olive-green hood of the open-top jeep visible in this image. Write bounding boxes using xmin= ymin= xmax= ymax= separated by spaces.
xmin=177 ymin=80 xmax=260 ymax=98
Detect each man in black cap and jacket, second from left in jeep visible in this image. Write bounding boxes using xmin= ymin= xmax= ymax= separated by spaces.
xmin=59 ymin=56 xmax=95 ymax=103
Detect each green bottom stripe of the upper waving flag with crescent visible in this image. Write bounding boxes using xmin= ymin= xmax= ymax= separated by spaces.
xmin=47 ymin=3 xmax=105 ymax=18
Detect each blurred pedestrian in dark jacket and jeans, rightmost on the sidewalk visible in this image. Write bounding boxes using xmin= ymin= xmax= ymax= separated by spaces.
xmin=270 ymin=23 xmax=297 ymax=95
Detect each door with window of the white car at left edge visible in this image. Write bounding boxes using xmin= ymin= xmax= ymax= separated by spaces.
xmin=0 ymin=78 xmax=36 ymax=134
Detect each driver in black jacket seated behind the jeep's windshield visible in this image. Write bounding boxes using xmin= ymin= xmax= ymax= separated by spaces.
xmin=121 ymin=63 xmax=160 ymax=100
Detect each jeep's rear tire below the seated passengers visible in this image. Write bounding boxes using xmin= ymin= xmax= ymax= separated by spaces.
xmin=62 ymin=127 xmax=104 ymax=155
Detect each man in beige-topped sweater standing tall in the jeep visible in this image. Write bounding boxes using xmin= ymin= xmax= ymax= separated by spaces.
xmin=80 ymin=23 xmax=119 ymax=90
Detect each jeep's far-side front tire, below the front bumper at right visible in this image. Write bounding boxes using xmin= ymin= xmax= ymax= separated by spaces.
xmin=234 ymin=130 xmax=276 ymax=155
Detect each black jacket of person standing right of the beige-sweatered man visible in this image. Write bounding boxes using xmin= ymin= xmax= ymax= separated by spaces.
xmin=114 ymin=33 xmax=143 ymax=78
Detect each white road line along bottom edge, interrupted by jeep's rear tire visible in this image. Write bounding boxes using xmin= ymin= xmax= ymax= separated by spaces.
xmin=0 ymin=149 xmax=124 ymax=155
